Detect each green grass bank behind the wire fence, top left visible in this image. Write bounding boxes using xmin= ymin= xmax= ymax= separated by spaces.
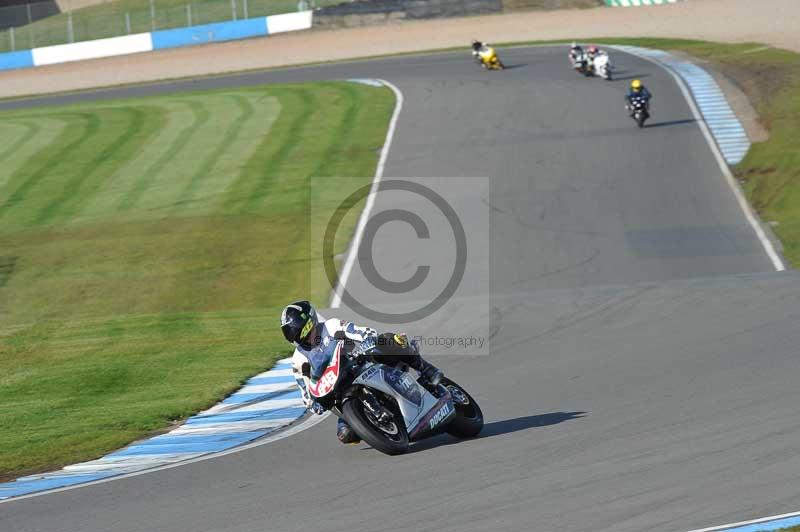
xmin=0 ymin=0 xmax=342 ymax=52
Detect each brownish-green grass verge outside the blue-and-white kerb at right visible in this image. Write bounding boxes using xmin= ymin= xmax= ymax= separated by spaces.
xmin=580 ymin=39 xmax=800 ymax=268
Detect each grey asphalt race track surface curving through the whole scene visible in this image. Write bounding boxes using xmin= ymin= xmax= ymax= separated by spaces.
xmin=0 ymin=47 xmax=800 ymax=532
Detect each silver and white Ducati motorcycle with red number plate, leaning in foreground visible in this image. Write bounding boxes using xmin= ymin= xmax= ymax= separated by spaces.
xmin=302 ymin=339 xmax=483 ymax=455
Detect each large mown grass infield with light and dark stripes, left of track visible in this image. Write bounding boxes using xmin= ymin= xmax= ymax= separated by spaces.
xmin=0 ymin=82 xmax=394 ymax=479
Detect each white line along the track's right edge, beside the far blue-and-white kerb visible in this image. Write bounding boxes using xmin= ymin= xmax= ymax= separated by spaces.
xmin=611 ymin=46 xmax=786 ymax=272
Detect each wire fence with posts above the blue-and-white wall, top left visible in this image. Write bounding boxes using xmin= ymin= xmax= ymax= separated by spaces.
xmin=0 ymin=0 xmax=338 ymax=52
